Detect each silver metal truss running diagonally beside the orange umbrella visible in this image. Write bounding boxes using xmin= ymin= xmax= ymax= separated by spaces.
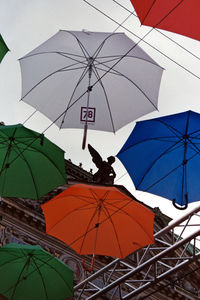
xmin=75 ymin=206 xmax=200 ymax=300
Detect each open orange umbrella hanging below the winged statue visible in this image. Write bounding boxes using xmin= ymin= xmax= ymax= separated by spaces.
xmin=41 ymin=184 xmax=154 ymax=268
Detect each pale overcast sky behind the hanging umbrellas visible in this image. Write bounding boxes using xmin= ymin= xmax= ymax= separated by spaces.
xmin=0 ymin=0 xmax=200 ymax=218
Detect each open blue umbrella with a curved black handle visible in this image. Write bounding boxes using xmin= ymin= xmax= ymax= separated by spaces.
xmin=117 ymin=111 xmax=200 ymax=209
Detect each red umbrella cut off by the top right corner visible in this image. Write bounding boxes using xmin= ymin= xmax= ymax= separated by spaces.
xmin=131 ymin=0 xmax=200 ymax=40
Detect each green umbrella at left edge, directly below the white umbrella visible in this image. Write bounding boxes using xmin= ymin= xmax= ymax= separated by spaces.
xmin=0 ymin=124 xmax=66 ymax=199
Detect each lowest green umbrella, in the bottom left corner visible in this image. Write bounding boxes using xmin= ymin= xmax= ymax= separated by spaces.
xmin=0 ymin=243 xmax=73 ymax=300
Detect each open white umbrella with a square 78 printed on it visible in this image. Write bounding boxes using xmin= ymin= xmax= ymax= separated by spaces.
xmin=20 ymin=30 xmax=163 ymax=148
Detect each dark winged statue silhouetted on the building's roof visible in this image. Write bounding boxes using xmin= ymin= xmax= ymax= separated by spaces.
xmin=88 ymin=144 xmax=116 ymax=184
